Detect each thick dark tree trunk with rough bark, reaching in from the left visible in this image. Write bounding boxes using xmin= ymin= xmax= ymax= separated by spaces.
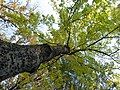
xmin=0 ymin=40 xmax=70 ymax=82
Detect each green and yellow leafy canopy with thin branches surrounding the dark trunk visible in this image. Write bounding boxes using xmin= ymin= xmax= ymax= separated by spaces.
xmin=0 ymin=0 xmax=120 ymax=90
